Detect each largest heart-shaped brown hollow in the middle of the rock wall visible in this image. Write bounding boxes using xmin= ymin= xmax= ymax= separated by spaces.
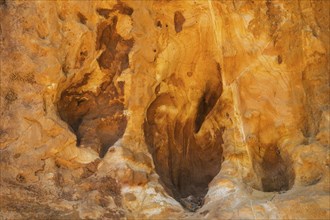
xmin=144 ymin=86 xmax=224 ymax=212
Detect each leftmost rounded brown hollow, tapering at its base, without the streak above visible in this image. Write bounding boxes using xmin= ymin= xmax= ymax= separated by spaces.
xmin=57 ymin=79 xmax=127 ymax=158
